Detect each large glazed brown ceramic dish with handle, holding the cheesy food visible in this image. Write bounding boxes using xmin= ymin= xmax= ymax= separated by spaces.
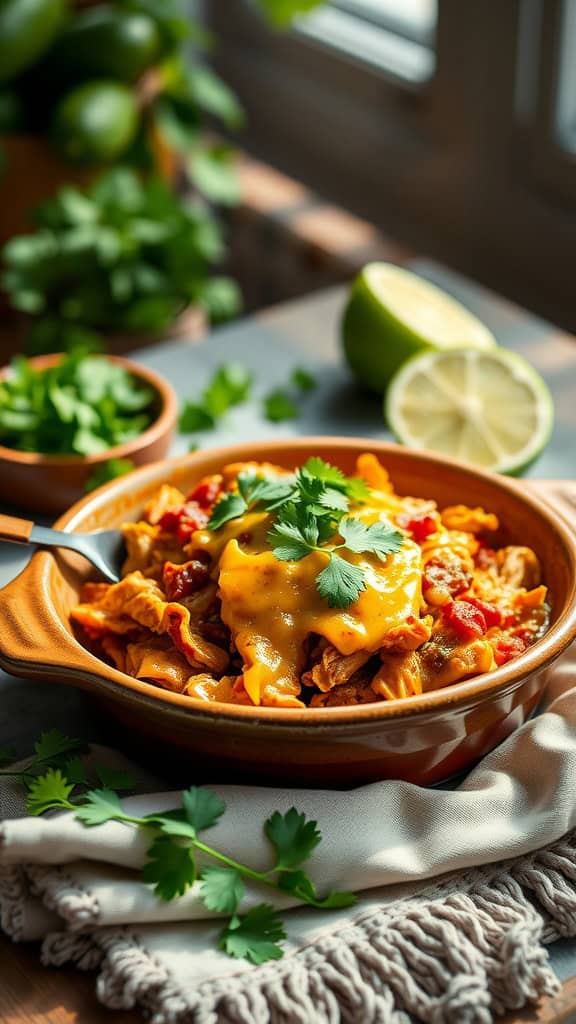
xmin=0 ymin=437 xmax=576 ymax=786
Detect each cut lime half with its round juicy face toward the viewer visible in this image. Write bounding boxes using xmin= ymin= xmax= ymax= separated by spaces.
xmin=385 ymin=348 xmax=553 ymax=474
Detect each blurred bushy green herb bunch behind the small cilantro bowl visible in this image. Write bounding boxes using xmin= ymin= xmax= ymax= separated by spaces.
xmin=2 ymin=167 xmax=239 ymax=352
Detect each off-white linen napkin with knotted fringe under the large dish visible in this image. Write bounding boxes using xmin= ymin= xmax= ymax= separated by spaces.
xmin=0 ymin=649 xmax=576 ymax=1024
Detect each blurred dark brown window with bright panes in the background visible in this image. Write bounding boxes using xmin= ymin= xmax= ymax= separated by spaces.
xmin=207 ymin=0 xmax=576 ymax=329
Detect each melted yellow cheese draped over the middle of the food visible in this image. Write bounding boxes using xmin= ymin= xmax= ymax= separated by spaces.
xmin=194 ymin=496 xmax=422 ymax=707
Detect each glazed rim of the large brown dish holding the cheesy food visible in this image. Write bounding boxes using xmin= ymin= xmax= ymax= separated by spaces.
xmin=0 ymin=436 xmax=576 ymax=729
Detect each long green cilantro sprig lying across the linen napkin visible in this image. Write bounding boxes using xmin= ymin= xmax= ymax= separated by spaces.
xmin=11 ymin=730 xmax=356 ymax=964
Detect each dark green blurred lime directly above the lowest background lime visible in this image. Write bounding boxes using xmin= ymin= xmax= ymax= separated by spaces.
xmin=55 ymin=4 xmax=162 ymax=82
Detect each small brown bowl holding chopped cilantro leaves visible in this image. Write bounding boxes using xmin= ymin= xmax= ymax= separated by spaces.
xmin=0 ymin=355 xmax=177 ymax=515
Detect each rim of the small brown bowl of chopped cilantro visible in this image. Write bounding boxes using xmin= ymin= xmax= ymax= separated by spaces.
xmin=0 ymin=352 xmax=178 ymax=469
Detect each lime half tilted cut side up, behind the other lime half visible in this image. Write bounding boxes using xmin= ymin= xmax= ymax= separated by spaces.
xmin=342 ymin=263 xmax=496 ymax=394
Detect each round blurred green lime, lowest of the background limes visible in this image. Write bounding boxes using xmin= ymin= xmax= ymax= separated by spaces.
xmin=52 ymin=79 xmax=138 ymax=164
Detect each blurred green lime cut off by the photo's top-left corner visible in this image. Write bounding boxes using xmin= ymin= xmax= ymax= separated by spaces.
xmin=0 ymin=0 xmax=68 ymax=82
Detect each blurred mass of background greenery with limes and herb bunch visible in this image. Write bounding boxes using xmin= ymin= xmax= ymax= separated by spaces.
xmin=0 ymin=0 xmax=319 ymax=352
